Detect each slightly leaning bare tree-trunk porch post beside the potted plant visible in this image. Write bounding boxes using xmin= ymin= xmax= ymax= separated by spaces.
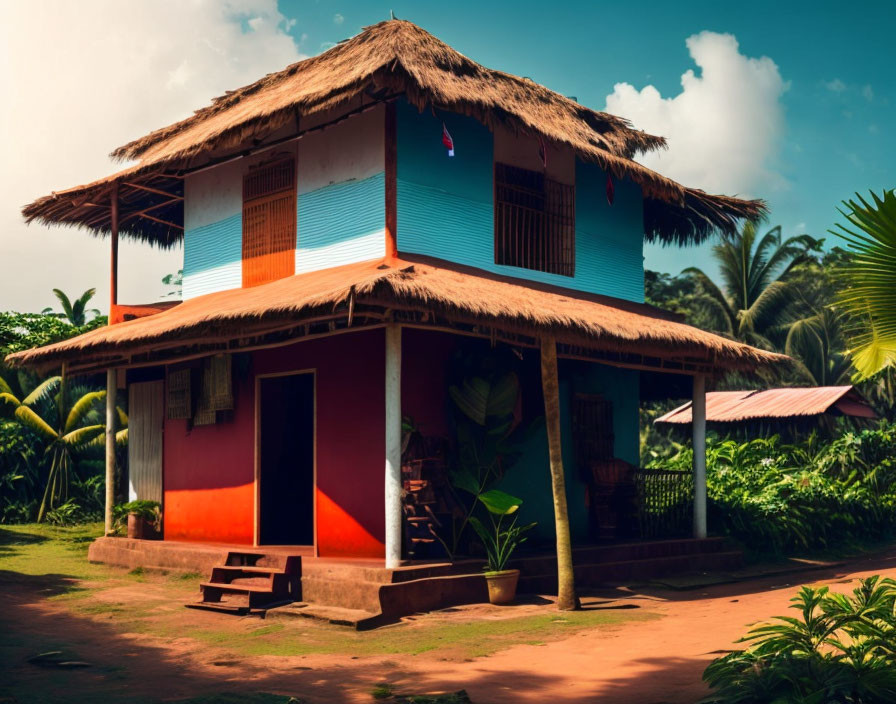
xmin=541 ymin=338 xmax=579 ymax=611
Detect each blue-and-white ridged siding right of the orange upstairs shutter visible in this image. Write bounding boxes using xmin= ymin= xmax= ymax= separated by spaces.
xmin=296 ymin=172 xmax=386 ymax=273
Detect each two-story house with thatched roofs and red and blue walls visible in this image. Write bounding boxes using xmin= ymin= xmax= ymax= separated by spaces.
xmin=11 ymin=20 xmax=780 ymax=612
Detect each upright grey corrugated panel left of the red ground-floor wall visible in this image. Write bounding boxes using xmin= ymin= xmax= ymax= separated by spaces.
xmin=128 ymin=381 xmax=165 ymax=503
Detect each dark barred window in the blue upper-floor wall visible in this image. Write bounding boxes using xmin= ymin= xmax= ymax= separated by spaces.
xmin=495 ymin=163 xmax=576 ymax=276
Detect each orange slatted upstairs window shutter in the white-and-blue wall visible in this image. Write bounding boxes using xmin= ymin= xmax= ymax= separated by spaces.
xmin=243 ymin=157 xmax=296 ymax=286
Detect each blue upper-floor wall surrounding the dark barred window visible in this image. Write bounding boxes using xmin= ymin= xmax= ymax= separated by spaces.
xmin=396 ymin=101 xmax=644 ymax=301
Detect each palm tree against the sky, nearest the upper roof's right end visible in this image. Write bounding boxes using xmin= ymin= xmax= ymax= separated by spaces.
xmin=683 ymin=222 xmax=821 ymax=349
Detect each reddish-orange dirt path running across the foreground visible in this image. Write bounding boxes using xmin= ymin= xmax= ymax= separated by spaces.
xmin=3 ymin=549 xmax=896 ymax=704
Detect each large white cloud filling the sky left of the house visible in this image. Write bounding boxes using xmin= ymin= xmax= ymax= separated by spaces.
xmin=0 ymin=0 xmax=300 ymax=311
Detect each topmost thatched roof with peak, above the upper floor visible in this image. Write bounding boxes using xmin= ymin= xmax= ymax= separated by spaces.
xmin=23 ymin=20 xmax=764 ymax=246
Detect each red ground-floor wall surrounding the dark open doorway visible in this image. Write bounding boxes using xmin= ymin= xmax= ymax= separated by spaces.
xmin=164 ymin=330 xmax=385 ymax=557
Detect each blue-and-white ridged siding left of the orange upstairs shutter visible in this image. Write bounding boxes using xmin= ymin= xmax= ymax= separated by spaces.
xmin=183 ymin=215 xmax=243 ymax=299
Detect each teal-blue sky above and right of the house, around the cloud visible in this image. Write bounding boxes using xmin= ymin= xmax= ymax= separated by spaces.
xmin=279 ymin=0 xmax=896 ymax=272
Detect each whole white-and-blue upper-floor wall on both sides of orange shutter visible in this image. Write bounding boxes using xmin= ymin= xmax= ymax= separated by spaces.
xmin=183 ymin=105 xmax=385 ymax=299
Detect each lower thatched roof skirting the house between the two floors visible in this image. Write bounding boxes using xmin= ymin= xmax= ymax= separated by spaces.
xmin=7 ymin=257 xmax=787 ymax=371
